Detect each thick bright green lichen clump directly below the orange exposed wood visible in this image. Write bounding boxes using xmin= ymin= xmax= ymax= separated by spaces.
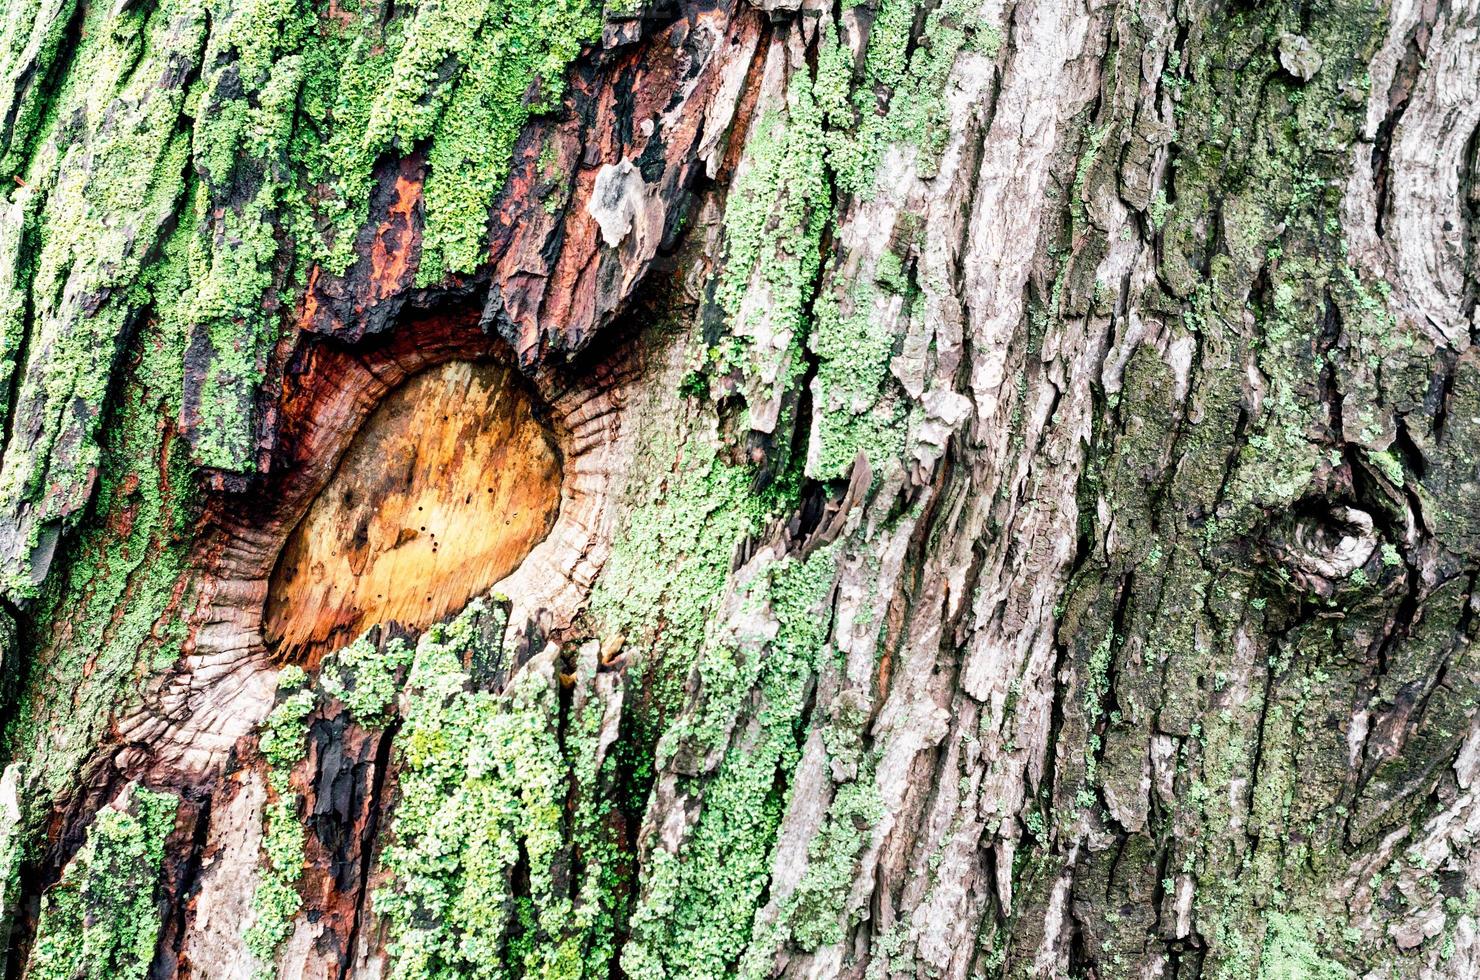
xmin=374 ymin=601 xmax=610 ymax=980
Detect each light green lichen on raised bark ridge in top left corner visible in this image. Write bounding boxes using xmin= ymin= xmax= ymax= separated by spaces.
xmin=0 ymin=0 xmax=206 ymax=598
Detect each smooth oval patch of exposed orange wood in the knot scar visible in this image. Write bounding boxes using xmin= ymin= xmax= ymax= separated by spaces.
xmin=265 ymin=361 xmax=561 ymax=662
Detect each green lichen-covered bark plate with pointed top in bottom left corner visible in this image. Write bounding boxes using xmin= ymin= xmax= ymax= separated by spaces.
xmin=25 ymin=788 xmax=179 ymax=980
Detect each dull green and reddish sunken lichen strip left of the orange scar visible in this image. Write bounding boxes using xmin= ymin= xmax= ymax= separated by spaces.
xmin=4 ymin=189 xmax=198 ymax=795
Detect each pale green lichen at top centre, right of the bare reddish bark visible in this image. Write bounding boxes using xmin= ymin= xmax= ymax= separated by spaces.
xmin=703 ymin=0 xmax=1000 ymax=480
